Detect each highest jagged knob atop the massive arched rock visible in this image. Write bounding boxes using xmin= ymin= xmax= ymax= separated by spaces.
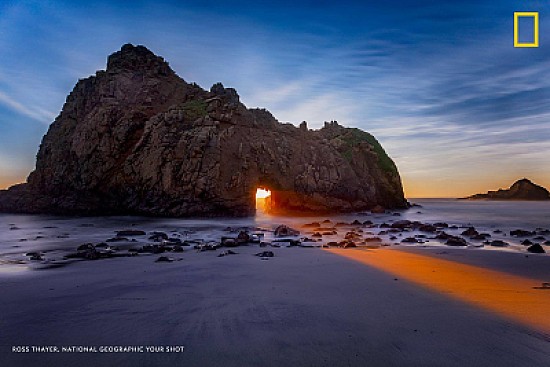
xmin=107 ymin=43 xmax=174 ymax=75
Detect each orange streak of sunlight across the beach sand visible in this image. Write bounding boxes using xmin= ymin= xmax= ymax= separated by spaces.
xmin=327 ymin=249 xmax=550 ymax=333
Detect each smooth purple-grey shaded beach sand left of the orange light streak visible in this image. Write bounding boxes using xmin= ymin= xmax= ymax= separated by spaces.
xmin=0 ymin=246 xmax=550 ymax=367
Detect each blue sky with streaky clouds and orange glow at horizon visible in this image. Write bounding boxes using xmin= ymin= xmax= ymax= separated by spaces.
xmin=0 ymin=0 xmax=550 ymax=198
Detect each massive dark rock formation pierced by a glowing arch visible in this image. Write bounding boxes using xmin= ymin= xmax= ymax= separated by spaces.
xmin=0 ymin=44 xmax=407 ymax=216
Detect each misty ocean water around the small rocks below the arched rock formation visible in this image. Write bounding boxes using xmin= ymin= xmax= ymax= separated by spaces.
xmin=0 ymin=199 xmax=550 ymax=272
